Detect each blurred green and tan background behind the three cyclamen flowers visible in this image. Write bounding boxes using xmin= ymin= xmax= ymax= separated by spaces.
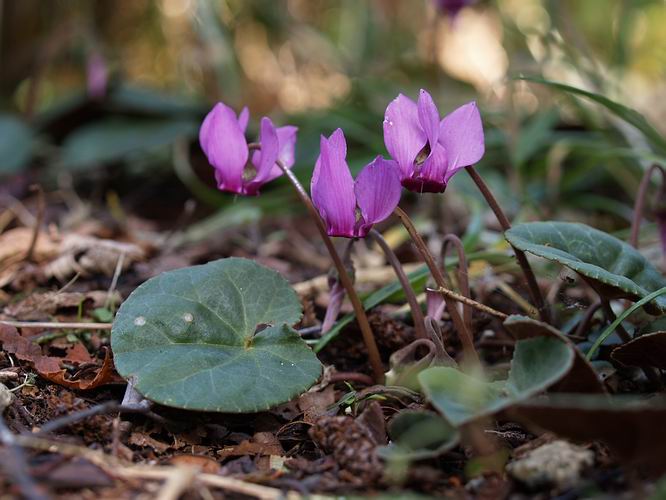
xmin=0 ymin=0 xmax=666 ymax=237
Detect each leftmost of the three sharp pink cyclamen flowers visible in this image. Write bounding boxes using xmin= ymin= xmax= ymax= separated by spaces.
xmin=199 ymin=102 xmax=298 ymax=196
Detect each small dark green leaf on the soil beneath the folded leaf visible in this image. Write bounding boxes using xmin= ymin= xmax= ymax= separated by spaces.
xmin=378 ymin=410 xmax=460 ymax=462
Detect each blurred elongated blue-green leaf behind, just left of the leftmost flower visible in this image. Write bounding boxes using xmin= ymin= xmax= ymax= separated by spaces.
xmin=61 ymin=118 xmax=197 ymax=170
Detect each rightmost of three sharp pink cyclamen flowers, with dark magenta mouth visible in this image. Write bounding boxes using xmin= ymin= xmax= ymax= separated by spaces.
xmin=384 ymin=90 xmax=485 ymax=193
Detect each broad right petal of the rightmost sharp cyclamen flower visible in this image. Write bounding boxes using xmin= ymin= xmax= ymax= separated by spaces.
xmin=439 ymin=101 xmax=485 ymax=182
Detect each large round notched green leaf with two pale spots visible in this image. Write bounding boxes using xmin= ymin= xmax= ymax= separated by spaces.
xmin=111 ymin=258 xmax=321 ymax=413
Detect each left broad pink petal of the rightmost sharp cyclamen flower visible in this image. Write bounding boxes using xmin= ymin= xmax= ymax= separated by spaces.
xmin=384 ymin=94 xmax=427 ymax=177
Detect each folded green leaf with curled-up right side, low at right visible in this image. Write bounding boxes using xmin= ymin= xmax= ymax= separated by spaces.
xmin=418 ymin=337 xmax=574 ymax=427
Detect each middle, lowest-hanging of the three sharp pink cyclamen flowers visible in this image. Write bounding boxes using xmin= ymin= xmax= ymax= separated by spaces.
xmin=310 ymin=129 xmax=401 ymax=238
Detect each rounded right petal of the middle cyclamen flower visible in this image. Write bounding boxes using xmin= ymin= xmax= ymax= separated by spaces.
xmin=354 ymin=156 xmax=402 ymax=237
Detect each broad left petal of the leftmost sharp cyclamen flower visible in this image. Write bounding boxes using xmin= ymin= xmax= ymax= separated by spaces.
xmin=199 ymin=102 xmax=248 ymax=194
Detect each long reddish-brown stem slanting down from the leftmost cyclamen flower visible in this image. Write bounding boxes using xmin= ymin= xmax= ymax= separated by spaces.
xmin=276 ymin=160 xmax=384 ymax=384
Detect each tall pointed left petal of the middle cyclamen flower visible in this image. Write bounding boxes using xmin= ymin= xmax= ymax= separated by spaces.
xmin=310 ymin=129 xmax=356 ymax=238
